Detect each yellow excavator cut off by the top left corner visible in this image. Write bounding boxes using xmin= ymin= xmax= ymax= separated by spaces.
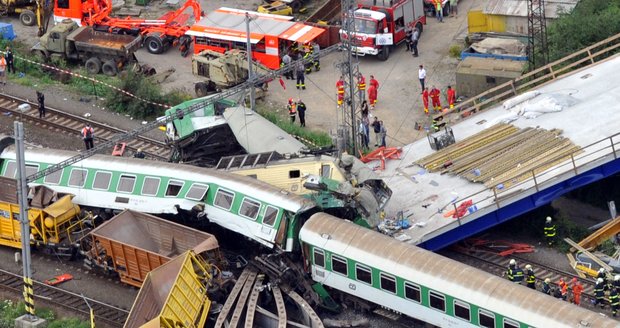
xmin=0 ymin=0 xmax=54 ymax=36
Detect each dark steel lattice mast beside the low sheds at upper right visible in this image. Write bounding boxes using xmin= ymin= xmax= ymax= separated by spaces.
xmin=527 ymin=0 xmax=549 ymax=71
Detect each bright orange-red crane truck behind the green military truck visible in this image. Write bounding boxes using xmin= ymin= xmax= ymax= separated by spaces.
xmin=54 ymin=0 xmax=202 ymax=56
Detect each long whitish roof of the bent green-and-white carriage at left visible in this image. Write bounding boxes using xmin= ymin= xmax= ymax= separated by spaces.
xmin=0 ymin=146 xmax=314 ymax=212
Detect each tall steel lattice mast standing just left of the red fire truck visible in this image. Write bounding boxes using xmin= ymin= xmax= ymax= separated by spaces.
xmin=336 ymin=0 xmax=362 ymax=156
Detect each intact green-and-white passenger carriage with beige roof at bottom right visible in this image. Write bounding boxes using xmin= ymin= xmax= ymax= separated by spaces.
xmin=300 ymin=213 xmax=620 ymax=328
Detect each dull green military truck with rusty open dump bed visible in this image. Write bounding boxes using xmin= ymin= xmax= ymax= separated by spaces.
xmin=31 ymin=19 xmax=141 ymax=76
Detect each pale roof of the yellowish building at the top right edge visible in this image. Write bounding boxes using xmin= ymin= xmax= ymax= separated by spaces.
xmin=483 ymin=0 xmax=579 ymax=18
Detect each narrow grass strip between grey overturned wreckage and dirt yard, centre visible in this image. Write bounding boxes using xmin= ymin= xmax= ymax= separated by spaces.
xmin=256 ymin=104 xmax=332 ymax=147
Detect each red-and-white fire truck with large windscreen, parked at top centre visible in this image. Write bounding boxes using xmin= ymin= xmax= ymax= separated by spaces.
xmin=340 ymin=0 xmax=426 ymax=60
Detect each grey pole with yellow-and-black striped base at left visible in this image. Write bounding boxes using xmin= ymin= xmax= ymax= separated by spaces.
xmin=13 ymin=122 xmax=45 ymax=327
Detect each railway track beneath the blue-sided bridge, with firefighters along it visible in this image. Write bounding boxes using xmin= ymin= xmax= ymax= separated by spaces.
xmin=443 ymin=247 xmax=610 ymax=311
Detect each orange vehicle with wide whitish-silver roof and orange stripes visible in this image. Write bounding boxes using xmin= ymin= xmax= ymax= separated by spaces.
xmin=185 ymin=7 xmax=325 ymax=69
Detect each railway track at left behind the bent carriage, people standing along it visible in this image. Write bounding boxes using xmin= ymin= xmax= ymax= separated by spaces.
xmin=0 ymin=94 xmax=171 ymax=161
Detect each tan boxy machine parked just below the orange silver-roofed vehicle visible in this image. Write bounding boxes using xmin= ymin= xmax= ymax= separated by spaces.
xmin=192 ymin=49 xmax=271 ymax=97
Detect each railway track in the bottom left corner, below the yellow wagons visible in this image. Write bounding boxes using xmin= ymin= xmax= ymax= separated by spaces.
xmin=0 ymin=270 xmax=129 ymax=327
